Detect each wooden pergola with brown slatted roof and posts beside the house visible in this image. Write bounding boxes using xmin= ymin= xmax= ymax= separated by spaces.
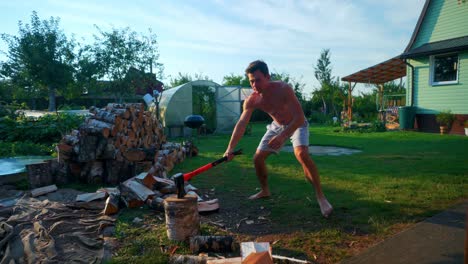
xmin=341 ymin=57 xmax=406 ymax=121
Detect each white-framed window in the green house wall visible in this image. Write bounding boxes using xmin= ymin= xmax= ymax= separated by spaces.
xmin=431 ymin=54 xmax=458 ymax=85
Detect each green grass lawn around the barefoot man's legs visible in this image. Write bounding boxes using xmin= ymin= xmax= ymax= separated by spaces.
xmin=113 ymin=124 xmax=468 ymax=263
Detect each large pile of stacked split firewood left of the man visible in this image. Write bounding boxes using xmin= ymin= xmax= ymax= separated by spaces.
xmin=57 ymin=103 xmax=192 ymax=185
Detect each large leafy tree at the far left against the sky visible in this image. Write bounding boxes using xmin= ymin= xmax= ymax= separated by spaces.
xmin=0 ymin=11 xmax=75 ymax=111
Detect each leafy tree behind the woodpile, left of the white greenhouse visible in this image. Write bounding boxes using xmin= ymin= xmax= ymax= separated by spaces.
xmin=92 ymin=26 xmax=164 ymax=101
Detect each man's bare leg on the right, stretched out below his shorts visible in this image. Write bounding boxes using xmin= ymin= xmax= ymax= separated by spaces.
xmin=294 ymin=146 xmax=333 ymax=217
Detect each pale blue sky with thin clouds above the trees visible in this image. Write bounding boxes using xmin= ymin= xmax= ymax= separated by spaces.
xmin=0 ymin=0 xmax=424 ymax=94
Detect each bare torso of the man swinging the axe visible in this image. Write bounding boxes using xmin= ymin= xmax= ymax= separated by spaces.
xmin=248 ymin=82 xmax=297 ymax=125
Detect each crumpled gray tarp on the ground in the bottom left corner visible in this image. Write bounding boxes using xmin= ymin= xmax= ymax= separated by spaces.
xmin=0 ymin=196 xmax=115 ymax=264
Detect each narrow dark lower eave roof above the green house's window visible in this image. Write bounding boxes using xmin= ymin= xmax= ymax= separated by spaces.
xmin=400 ymin=36 xmax=468 ymax=59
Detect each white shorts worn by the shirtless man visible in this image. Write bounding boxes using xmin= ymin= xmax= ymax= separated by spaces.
xmin=257 ymin=120 xmax=309 ymax=153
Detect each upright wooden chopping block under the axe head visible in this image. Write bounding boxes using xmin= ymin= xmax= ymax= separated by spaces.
xmin=164 ymin=195 xmax=200 ymax=241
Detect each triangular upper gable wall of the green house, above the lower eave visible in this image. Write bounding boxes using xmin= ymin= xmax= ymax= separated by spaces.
xmin=412 ymin=0 xmax=468 ymax=48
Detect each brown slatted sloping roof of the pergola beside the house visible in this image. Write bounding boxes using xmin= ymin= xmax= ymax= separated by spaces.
xmin=341 ymin=57 xmax=406 ymax=84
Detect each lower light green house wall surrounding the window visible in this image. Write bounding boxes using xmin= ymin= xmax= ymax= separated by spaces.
xmin=406 ymin=51 xmax=468 ymax=114
